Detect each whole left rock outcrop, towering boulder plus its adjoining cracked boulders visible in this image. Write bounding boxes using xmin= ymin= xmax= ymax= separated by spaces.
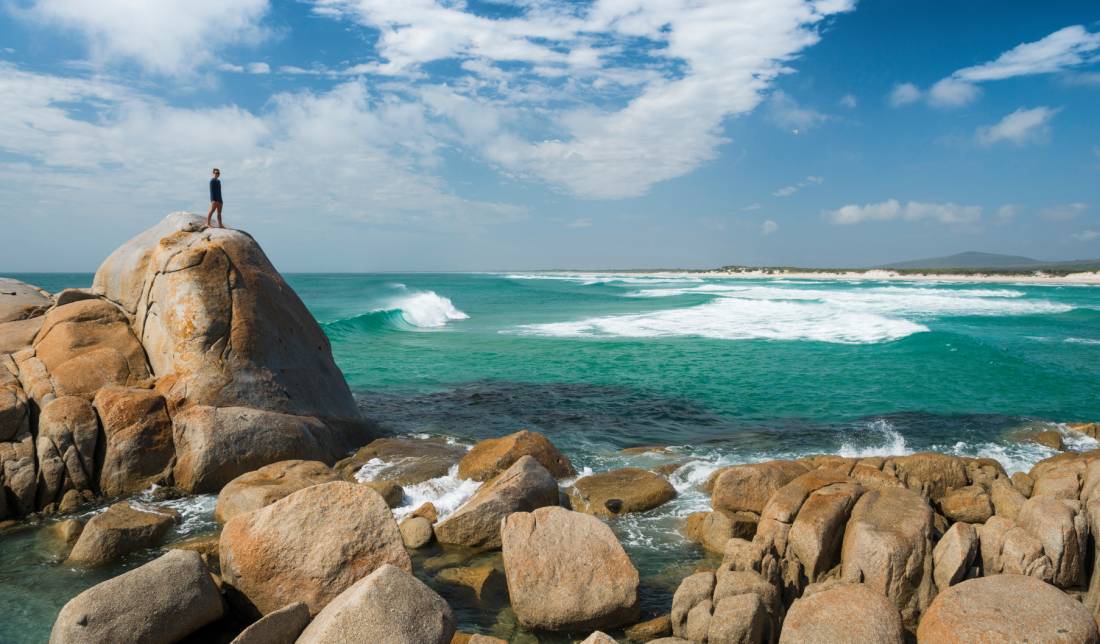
xmin=0 ymin=212 xmax=371 ymax=520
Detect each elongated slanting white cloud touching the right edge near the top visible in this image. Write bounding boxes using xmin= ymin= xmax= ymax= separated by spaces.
xmin=952 ymin=24 xmax=1100 ymax=83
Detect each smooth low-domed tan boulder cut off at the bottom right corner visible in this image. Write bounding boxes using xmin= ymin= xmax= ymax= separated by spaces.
xmin=916 ymin=575 xmax=1100 ymax=644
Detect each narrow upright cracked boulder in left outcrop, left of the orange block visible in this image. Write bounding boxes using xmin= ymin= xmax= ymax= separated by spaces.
xmin=35 ymin=396 xmax=99 ymax=507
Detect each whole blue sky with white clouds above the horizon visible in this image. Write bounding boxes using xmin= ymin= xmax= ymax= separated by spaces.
xmin=0 ymin=0 xmax=1100 ymax=272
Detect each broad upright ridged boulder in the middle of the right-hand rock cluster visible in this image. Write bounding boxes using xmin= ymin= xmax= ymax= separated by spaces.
xmin=840 ymin=489 xmax=935 ymax=627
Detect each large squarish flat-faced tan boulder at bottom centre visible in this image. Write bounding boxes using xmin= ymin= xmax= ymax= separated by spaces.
xmin=501 ymin=507 xmax=638 ymax=632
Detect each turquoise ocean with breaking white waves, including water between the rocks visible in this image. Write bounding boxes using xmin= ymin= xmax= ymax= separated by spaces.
xmin=0 ymin=272 xmax=1100 ymax=642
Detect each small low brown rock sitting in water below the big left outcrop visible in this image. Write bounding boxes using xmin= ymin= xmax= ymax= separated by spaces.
xmin=67 ymin=501 xmax=179 ymax=566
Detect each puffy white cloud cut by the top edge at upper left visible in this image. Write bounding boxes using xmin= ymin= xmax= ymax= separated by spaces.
xmin=20 ymin=0 xmax=268 ymax=75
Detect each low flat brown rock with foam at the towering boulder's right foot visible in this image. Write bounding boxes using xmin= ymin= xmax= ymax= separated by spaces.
xmin=334 ymin=438 xmax=466 ymax=485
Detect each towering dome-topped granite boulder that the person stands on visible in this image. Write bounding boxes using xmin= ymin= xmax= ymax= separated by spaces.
xmin=89 ymin=214 xmax=366 ymax=491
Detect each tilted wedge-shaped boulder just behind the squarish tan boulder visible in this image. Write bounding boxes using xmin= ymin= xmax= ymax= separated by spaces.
xmin=436 ymin=456 xmax=558 ymax=549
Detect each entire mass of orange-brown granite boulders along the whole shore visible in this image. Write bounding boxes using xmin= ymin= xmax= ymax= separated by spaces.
xmin=15 ymin=214 xmax=1100 ymax=644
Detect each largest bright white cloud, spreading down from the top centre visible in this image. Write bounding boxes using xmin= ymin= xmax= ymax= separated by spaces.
xmin=315 ymin=0 xmax=853 ymax=198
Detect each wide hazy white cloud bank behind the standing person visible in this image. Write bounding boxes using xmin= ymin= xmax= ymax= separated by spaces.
xmin=0 ymin=64 xmax=525 ymax=229
